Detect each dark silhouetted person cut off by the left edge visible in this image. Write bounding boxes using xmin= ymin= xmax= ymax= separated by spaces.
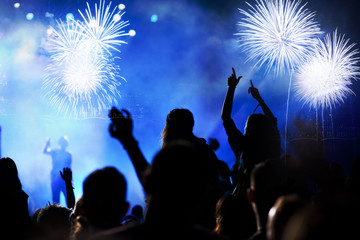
xmin=0 ymin=158 xmax=30 ymax=239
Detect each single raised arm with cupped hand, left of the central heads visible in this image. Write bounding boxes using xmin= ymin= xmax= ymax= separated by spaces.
xmin=109 ymin=107 xmax=149 ymax=187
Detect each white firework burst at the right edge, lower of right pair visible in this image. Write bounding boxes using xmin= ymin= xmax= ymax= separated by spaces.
xmin=294 ymin=30 xmax=360 ymax=109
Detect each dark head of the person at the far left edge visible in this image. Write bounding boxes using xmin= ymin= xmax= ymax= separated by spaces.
xmin=0 ymin=157 xmax=21 ymax=190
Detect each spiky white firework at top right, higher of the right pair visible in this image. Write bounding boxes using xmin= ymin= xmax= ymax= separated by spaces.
xmin=236 ymin=0 xmax=322 ymax=74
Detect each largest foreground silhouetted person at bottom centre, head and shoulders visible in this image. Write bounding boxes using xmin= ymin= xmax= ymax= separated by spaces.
xmin=91 ymin=140 xmax=229 ymax=240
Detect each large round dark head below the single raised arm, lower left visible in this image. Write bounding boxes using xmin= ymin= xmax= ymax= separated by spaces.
xmin=83 ymin=167 xmax=129 ymax=229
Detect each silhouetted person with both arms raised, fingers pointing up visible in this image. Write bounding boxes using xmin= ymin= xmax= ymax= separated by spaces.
xmin=221 ymin=68 xmax=281 ymax=197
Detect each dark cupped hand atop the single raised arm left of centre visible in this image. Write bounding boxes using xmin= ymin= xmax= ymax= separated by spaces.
xmin=109 ymin=107 xmax=133 ymax=143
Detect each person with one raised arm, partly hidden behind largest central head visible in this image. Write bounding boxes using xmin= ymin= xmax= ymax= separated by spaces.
xmin=109 ymin=107 xmax=222 ymax=201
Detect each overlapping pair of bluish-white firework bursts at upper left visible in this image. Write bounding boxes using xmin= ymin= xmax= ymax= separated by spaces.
xmin=42 ymin=1 xmax=129 ymax=118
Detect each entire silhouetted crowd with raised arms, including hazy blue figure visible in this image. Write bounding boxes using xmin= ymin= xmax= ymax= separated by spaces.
xmin=0 ymin=69 xmax=360 ymax=240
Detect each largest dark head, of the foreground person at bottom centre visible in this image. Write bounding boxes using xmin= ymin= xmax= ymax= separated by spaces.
xmin=146 ymin=140 xmax=207 ymax=199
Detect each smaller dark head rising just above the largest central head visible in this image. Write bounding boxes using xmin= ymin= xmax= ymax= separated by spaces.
xmin=162 ymin=108 xmax=194 ymax=144
